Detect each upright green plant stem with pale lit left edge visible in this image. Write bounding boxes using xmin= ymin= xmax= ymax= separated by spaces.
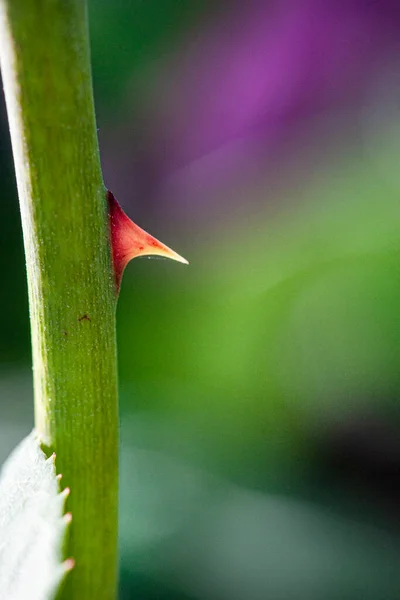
xmin=0 ymin=0 xmax=118 ymax=600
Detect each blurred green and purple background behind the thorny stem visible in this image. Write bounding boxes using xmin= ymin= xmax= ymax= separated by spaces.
xmin=0 ymin=0 xmax=400 ymax=600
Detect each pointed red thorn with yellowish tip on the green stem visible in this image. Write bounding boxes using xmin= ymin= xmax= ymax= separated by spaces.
xmin=107 ymin=190 xmax=188 ymax=291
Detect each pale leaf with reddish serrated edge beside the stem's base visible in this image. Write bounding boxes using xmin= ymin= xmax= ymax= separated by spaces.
xmin=0 ymin=431 xmax=73 ymax=600
